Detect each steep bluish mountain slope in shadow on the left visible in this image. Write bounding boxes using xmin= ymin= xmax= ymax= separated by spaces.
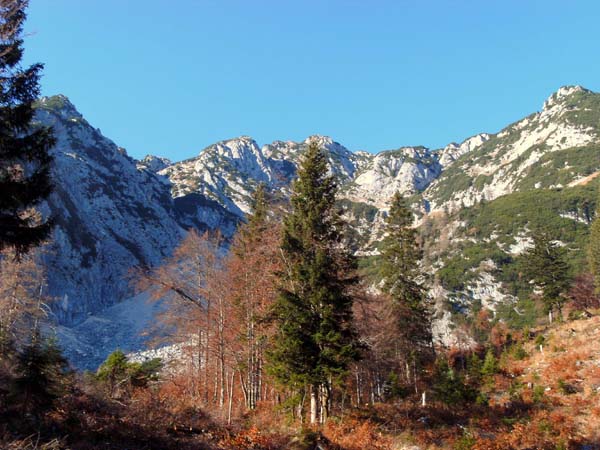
xmin=36 ymin=96 xmax=239 ymax=325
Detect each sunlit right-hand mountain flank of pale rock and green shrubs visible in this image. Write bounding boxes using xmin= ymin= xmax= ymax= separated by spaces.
xmin=415 ymin=87 xmax=600 ymax=336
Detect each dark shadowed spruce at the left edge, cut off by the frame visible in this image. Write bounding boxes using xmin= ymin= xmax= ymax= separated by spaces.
xmin=0 ymin=0 xmax=54 ymax=256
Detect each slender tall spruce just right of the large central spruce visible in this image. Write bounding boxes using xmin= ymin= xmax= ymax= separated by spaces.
xmin=381 ymin=192 xmax=433 ymax=381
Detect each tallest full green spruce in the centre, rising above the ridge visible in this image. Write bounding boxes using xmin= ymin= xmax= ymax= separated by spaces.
xmin=269 ymin=143 xmax=359 ymax=423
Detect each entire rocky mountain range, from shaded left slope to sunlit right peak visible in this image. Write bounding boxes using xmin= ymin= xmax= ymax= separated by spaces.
xmin=37 ymin=86 xmax=600 ymax=368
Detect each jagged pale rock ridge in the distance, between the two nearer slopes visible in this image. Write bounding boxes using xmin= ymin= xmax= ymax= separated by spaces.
xmin=159 ymin=136 xmax=442 ymax=216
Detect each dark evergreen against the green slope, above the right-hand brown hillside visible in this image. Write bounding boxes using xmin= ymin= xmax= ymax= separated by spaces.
xmin=524 ymin=230 xmax=571 ymax=320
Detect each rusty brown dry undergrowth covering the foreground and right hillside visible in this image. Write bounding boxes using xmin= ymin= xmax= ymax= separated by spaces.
xmin=0 ymin=311 xmax=600 ymax=450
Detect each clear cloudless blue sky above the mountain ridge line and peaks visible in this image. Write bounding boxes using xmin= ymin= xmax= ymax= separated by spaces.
xmin=25 ymin=0 xmax=600 ymax=160
